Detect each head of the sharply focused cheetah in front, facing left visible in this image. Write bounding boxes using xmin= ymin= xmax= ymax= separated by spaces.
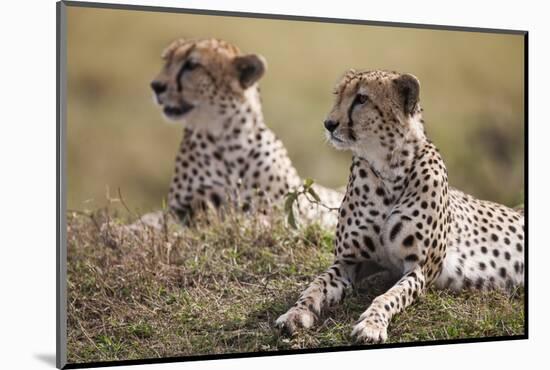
xmin=324 ymin=70 xmax=424 ymax=163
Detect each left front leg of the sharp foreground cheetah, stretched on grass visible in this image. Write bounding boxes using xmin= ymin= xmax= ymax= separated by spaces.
xmin=275 ymin=260 xmax=352 ymax=335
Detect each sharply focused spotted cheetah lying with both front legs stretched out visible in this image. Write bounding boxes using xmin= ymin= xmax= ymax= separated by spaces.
xmin=276 ymin=70 xmax=524 ymax=343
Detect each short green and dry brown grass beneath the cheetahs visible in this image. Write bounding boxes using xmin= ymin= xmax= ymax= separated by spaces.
xmin=67 ymin=211 xmax=524 ymax=362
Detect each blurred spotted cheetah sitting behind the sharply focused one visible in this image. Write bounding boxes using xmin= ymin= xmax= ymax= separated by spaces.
xmin=144 ymin=39 xmax=343 ymax=228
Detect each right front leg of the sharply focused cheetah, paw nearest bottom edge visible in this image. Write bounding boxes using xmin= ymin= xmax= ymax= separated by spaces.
xmin=351 ymin=266 xmax=426 ymax=343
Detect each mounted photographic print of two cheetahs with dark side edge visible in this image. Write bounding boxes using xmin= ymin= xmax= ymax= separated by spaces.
xmin=57 ymin=1 xmax=528 ymax=368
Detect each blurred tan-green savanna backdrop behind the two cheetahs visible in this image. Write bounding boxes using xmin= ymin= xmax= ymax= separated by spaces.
xmin=67 ymin=7 xmax=524 ymax=212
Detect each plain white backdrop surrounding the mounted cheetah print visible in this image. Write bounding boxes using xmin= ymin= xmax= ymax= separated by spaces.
xmin=0 ymin=0 xmax=550 ymax=370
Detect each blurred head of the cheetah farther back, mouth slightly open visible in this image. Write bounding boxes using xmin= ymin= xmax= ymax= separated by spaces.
xmin=151 ymin=39 xmax=266 ymax=128
